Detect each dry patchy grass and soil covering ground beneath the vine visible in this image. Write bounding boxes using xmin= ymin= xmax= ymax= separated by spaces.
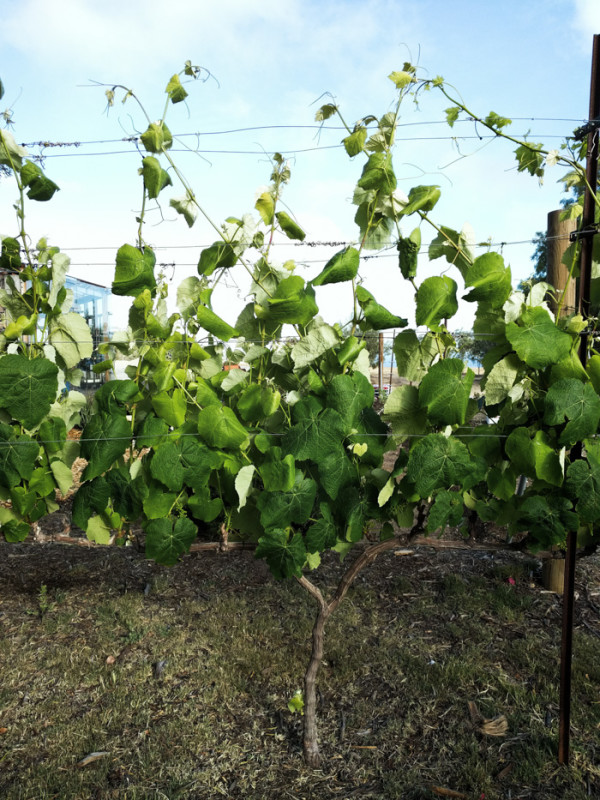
xmin=0 ymin=549 xmax=600 ymax=800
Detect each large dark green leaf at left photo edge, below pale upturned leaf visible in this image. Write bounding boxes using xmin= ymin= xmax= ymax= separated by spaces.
xmin=0 ymin=354 xmax=58 ymax=429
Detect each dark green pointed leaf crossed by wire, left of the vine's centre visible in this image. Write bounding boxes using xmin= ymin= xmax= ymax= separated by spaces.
xmin=80 ymin=413 xmax=131 ymax=481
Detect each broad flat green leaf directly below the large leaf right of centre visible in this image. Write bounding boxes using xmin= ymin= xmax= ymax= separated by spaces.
xmin=406 ymin=433 xmax=473 ymax=498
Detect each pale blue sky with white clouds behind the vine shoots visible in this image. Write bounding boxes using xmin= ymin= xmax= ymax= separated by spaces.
xmin=0 ymin=0 xmax=600 ymax=327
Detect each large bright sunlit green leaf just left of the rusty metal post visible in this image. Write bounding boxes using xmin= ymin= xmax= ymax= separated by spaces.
xmin=506 ymin=306 xmax=573 ymax=369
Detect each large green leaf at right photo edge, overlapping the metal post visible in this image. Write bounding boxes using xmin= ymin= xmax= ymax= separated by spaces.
xmin=544 ymin=378 xmax=600 ymax=446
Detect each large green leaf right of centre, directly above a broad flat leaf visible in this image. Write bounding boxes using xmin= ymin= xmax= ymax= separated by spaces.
xmin=419 ymin=358 xmax=475 ymax=425
